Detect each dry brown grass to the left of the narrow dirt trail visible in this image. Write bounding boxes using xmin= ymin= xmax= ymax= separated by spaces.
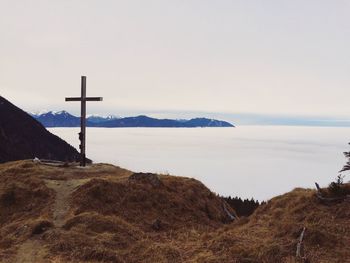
xmin=0 ymin=162 xmax=54 ymax=258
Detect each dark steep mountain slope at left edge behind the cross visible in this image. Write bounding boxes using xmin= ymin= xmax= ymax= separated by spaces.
xmin=0 ymin=96 xmax=79 ymax=163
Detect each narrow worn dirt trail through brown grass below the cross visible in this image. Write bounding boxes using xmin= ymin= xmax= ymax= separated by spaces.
xmin=13 ymin=179 xmax=90 ymax=263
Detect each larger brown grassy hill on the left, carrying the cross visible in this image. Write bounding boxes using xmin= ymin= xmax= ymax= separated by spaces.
xmin=0 ymin=161 xmax=234 ymax=262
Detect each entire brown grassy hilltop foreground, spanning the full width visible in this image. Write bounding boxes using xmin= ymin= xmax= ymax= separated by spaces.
xmin=0 ymin=161 xmax=350 ymax=263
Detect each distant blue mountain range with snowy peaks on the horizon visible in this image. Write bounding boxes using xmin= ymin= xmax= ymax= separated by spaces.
xmin=31 ymin=111 xmax=234 ymax=128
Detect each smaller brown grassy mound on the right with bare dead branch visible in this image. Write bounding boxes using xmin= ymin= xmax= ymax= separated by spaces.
xmin=205 ymin=189 xmax=350 ymax=262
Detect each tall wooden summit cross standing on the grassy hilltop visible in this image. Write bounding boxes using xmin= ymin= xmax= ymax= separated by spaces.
xmin=66 ymin=76 xmax=103 ymax=166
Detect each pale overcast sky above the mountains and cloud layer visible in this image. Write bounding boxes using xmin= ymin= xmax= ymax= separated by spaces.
xmin=0 ymin=0 xmax=350 ymax=117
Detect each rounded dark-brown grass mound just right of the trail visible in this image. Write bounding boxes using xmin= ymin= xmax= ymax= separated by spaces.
xmin=72 ymin=176 xmax=230 ymax=231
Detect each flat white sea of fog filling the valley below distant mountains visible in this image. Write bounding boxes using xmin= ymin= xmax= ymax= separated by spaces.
xmin=49 ymin=126 xmax=350 ymax=200
